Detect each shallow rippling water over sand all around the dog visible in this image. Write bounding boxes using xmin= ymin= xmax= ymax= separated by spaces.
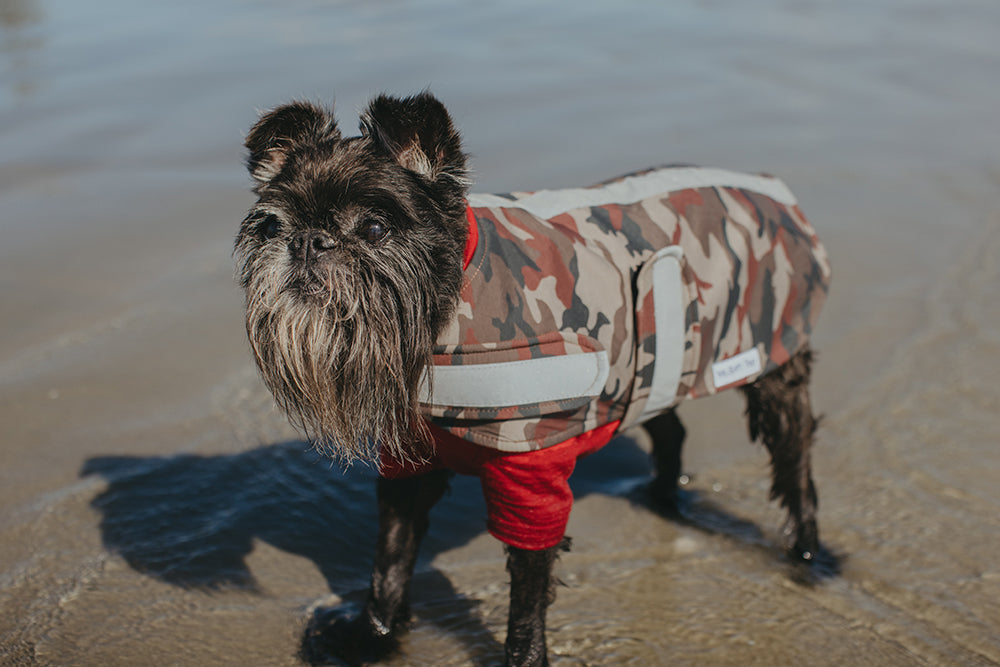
xmin=0 ymin=0 xmax=1000 ymax=665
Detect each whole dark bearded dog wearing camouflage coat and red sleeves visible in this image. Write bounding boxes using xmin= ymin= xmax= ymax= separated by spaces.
xmin=234 ymin=92 xmax=830 ymax=665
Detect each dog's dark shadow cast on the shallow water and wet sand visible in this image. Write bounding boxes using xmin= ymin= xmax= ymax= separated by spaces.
xmin=81 ymin=437 xmax=840 ymax=663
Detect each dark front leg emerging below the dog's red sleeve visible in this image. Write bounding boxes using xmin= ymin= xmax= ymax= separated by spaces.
xmin=504 ymin=540 xmax=567 ymax=667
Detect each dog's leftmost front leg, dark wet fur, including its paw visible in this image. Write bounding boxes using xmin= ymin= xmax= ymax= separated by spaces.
xmin=303 ymin=470 xmax=451 ymax=665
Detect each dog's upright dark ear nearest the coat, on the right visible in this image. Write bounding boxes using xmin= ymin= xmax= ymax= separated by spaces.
xmin=361 ymin=92 xmax=468 ymax=184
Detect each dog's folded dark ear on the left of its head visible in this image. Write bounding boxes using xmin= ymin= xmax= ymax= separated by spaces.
xmin=246 ymin=102 xmax=340 ymax=185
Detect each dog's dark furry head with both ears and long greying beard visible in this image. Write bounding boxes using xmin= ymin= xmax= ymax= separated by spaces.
xmin=235 ymin=93 xmax=467 ymax=460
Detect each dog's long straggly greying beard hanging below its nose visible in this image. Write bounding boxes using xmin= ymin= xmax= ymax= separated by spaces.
xmin=244 ymin=243 xmax=433 ymax=462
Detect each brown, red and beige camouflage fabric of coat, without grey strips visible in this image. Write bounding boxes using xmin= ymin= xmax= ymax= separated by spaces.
xmin=422 ymin=167 xmax=830 ymax=451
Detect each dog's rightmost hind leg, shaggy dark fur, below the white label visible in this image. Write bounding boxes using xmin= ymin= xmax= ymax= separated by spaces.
xmin=741 ymin=348 xmax=819 ymax=561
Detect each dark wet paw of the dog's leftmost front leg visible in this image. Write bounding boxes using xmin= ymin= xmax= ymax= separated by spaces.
xmin=299 ymin=604 xmax=399 ymax=667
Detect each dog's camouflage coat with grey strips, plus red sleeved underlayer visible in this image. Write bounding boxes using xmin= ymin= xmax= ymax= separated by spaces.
xmin=389 ymin=167 xmax=830 ymax=548
